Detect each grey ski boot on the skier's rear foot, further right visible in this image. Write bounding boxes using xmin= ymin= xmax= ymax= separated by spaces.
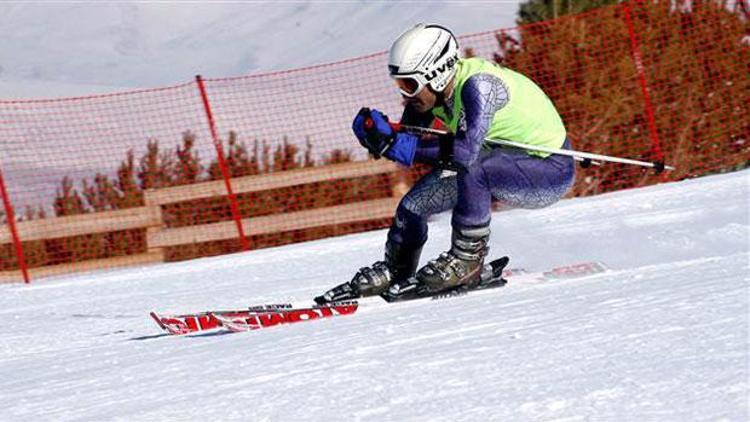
xmin=416 ymin=225 xmax=490 ymax=292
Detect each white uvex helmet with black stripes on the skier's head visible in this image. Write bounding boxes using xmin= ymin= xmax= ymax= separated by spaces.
xmin=388 ymin=23 xmax=458 ymax=97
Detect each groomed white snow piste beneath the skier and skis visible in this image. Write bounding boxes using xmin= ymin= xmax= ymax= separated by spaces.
xmin=0 ymin=171 xmax=750 ymax=421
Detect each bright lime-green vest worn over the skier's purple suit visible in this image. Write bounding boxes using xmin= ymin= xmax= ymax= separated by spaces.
xmin=432 ymin=58 xmax=566 ymax=157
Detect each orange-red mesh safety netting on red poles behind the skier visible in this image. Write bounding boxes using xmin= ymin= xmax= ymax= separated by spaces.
xmin=0 ymin=0 xmax=750 ymax=282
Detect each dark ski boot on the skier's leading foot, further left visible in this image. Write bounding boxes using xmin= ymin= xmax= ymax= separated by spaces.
xmin=315 ymin=240 xmax=422 ymax=305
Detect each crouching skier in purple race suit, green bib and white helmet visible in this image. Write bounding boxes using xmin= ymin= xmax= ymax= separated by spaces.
xmin=315 ymin=24 xmax=575 ymax=303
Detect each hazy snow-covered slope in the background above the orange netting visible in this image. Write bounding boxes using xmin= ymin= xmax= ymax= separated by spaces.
xmin=0 ymin=0 xmax=518 ymax=99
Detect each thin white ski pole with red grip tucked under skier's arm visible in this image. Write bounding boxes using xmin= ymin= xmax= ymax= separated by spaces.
xmin=391 ymin=123 xmax=675 ymax=174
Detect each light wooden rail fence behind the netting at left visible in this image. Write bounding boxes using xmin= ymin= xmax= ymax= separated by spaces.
xmin=0 ymin=160 xmax=406 ymax=282
